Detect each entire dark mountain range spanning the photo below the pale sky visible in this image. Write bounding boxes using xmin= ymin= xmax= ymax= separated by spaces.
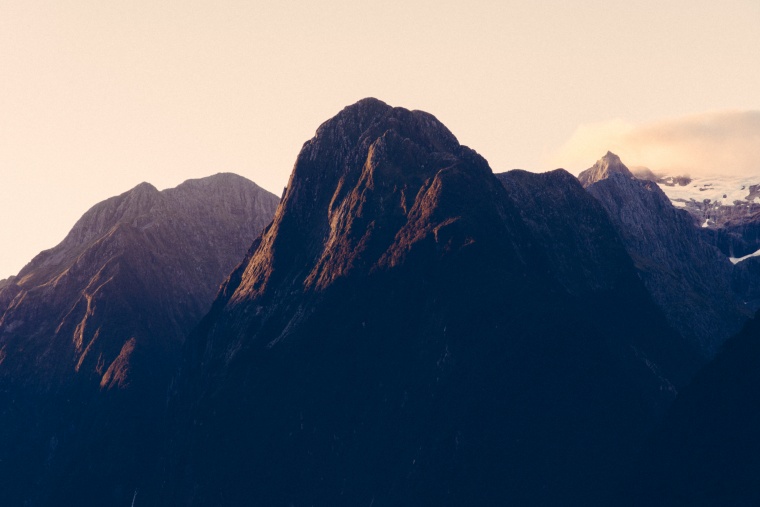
xmin=0 ymin=99 xmax=760 ymax=506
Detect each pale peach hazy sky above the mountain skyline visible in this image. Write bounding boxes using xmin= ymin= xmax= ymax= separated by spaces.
xmin=0 ymin=0 xmax=760 ymax=278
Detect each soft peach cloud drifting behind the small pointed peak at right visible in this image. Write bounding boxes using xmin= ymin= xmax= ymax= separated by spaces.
xmin=549 ymin=111 xmax=760 ymax=177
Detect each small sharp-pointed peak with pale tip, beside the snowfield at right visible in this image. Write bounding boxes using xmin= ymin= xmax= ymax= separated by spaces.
xmin=578 ymin=152 xmax=750 ymax=357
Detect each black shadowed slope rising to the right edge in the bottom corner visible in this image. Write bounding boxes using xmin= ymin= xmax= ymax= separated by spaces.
xmin=624 ymin=318 xmax=760 ymax=507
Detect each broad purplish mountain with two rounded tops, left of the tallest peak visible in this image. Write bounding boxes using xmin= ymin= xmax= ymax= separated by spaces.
xmin=0 ymin=174 xmax=278 ymax=505
